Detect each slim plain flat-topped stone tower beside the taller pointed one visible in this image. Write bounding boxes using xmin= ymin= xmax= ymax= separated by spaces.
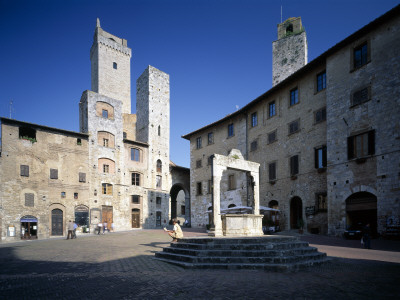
xmin=136 ymin=66 xmax=170 ymax=190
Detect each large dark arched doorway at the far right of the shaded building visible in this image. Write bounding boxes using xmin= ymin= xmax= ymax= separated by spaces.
xmin=346 ymin=192 xmax=378 ymax=234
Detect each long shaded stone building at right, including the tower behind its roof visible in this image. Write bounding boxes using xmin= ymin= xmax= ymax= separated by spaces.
xmin=183 ymin=6 xmax=400 ymax=235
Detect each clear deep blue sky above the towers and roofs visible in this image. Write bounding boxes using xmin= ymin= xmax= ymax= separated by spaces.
xmin=0 ymin=0 xmax=399 ymax=167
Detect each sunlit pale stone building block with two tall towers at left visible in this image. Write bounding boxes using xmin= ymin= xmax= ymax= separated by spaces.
xmin=0 ymin=20 xmax=190 ymax=241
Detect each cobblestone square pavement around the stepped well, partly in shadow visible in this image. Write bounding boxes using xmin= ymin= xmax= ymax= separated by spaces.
xmin=0 ymin=229 xmax=400 ymax=300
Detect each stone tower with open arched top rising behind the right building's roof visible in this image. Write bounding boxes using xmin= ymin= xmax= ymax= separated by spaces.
xmin=272 ymin=17 xmax=308 ymax=86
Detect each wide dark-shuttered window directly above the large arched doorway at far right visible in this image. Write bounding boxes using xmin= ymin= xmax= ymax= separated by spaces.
xmin=347 ymin=130 xmax=375 ymax=159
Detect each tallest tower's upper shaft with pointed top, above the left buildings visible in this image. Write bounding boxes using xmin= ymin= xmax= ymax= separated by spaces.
xmin=90 ymin=19 xmax=131 ymax=114
